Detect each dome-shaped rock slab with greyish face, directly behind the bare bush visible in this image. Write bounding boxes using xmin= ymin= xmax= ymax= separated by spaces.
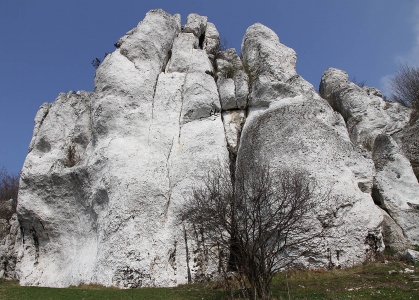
xmin=237 ymin=96 xmax=383 ymax=267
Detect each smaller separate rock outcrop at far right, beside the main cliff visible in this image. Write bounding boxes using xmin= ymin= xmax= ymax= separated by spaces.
xmin=320 ymin=68 xmax=419 ymax=249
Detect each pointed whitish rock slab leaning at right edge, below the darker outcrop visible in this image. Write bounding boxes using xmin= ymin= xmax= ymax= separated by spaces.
xmin=373 ymin=134 xmax=419 ymax=244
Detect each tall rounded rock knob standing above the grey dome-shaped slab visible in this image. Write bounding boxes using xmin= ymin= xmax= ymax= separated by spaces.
xmin=242 ymin=24 xmax=328 ymax=107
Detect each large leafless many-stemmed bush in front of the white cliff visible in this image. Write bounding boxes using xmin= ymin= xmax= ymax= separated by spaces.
xmin=182 ymin=158 xmax=333 ymax=299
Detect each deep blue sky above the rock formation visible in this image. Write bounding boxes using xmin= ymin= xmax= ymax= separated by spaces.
xmin=0 ymin=0 xmax=419 ymax=174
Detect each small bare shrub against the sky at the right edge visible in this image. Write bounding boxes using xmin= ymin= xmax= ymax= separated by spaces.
xmin=388 ymin=64 xmax=419 ymax=111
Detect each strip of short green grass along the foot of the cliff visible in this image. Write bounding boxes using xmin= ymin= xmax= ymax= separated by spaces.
xmin=0 ymin=260 xmax=419 ymax=300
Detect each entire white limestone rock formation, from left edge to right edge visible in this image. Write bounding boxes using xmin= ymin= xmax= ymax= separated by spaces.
xmin=0 ymin=10 xmax=419 ymax=288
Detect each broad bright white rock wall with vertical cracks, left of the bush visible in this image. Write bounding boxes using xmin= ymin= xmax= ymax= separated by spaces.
xmin=17 ymin=10 xmax=228 ymax=287
